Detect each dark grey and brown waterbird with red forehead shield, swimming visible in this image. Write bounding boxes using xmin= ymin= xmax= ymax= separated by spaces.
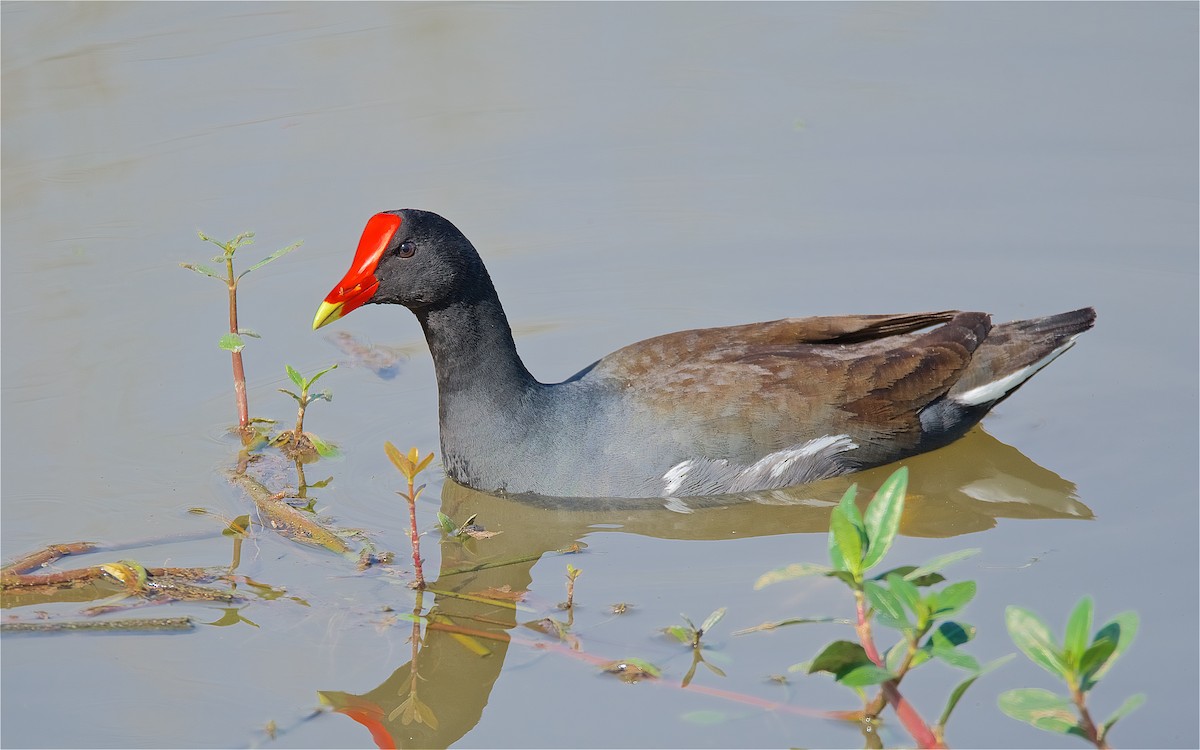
xmin=313 ymin=209 xmax=1096 ymax=497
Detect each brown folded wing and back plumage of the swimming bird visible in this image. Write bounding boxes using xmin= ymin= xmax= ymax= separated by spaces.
xmin=587 ymin=311 xmax=990 ymax=460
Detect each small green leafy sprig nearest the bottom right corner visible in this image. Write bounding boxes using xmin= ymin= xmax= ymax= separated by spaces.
xmin=997 ymin=596 xmax=1146 ymax=750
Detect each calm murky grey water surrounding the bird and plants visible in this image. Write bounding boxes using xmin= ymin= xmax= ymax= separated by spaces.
xmin=0 ymin=2 xmax=1200 ymax=748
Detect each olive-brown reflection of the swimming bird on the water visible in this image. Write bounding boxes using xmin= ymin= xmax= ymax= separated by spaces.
xmin=319 ymin=428 xmax=1092 ymax=748
